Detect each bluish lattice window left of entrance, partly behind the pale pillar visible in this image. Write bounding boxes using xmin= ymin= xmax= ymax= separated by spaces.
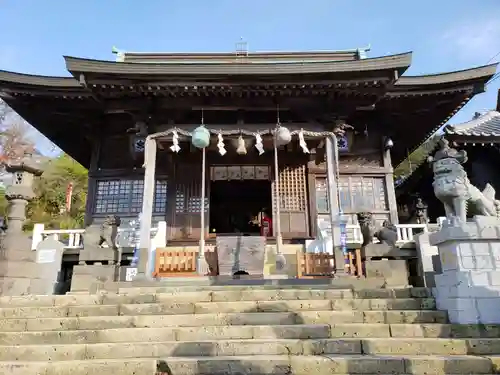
xmin=94 ymin=180 xmax=167 ymax=215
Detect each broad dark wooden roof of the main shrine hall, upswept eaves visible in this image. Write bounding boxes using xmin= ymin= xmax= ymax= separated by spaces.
xmin=0 ymin=52 xmax=496 ymax=166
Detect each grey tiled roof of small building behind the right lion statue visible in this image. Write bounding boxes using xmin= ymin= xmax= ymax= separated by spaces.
xmin=444 ymin=111 xmax=500 ymax=137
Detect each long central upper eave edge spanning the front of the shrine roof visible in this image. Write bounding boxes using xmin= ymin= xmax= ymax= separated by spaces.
xmin=64 ymin=52 xmax=412 ymax=75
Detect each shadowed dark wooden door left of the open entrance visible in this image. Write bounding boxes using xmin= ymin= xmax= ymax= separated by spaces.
xmin=169 ymin=163 xmax=209 ymax=240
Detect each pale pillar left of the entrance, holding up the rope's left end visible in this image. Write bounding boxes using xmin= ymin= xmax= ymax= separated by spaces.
xmin=137 ymin=137 xmax=156 ymax=277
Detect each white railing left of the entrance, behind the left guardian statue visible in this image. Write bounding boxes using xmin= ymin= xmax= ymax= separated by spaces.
xmin=31 ymin=225 xmax=166 ymax=250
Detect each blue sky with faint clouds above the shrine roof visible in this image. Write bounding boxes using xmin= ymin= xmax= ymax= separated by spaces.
xmin=0 ymin=0 xmax=500 ymax=153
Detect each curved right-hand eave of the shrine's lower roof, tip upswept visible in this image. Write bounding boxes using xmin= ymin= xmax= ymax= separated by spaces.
xmin=394 ymin=63 xmax=498 ymax=87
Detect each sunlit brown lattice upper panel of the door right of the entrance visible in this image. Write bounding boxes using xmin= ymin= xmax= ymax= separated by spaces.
xmin=273 ymin=165 xmax=307 ymax=211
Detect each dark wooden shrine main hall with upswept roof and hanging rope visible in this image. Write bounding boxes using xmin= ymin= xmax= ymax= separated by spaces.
xmin=0 ymin=49 xmax=496 ymax=280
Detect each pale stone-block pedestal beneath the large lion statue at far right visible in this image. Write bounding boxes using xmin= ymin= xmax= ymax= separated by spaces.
xmin=429 ymin=216 xmax=500 ymax=324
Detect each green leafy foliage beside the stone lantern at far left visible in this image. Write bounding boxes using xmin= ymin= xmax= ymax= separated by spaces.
xmin=26 ymin=154 xmax=88 ymax=229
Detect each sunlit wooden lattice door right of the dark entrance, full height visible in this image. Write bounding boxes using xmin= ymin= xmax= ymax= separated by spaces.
xmin=272 ymin=164 xmax=309 ymax=238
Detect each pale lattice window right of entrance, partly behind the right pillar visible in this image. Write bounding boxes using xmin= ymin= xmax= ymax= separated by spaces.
xmin=316 ymin=176 xmax=388 ymax=213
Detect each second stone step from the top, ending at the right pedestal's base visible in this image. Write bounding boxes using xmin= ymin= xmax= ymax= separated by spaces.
xmin=0 ymin=296 xmax=436 ymax=319
